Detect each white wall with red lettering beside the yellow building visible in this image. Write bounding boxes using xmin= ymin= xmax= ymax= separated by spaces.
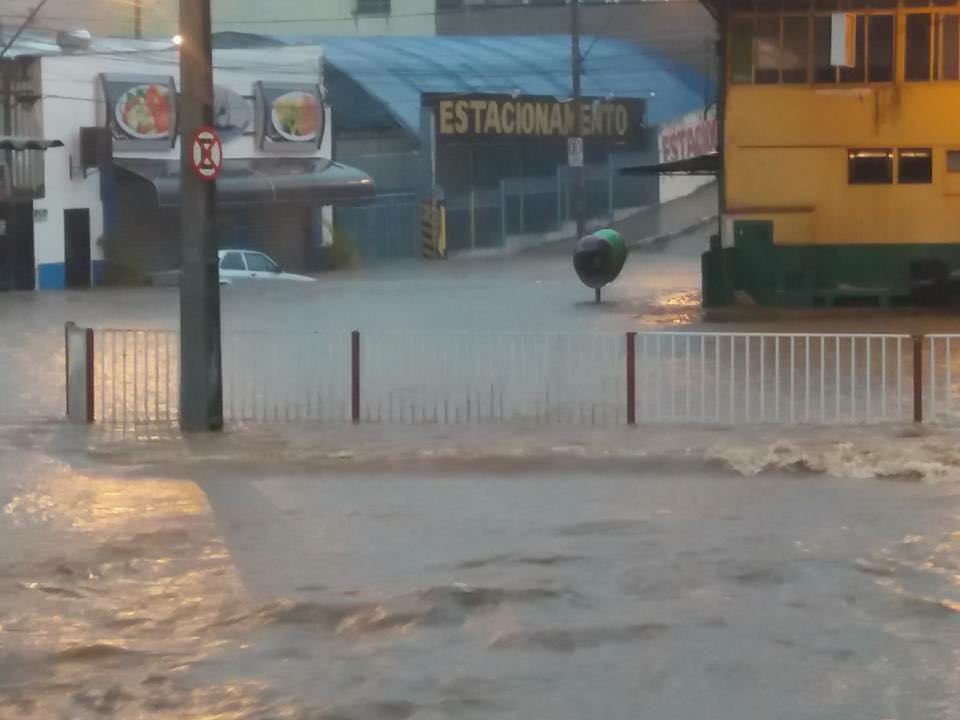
xmin=658 ymin=106 xmax=717 ymax=203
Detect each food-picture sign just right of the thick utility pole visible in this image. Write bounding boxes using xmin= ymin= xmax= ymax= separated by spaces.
xmin=254 ymin=82 xmax=324 ymax=152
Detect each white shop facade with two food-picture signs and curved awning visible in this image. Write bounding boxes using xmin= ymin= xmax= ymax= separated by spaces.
xmin=0 ymin=34 xmax=374 ymax=289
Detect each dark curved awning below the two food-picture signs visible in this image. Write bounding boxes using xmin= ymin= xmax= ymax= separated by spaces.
xmin=114 ymin=157 xmax=376 ymax=207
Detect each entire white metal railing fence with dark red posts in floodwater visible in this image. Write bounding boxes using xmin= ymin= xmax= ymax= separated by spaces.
xmin=80 ymin=330 xmax=936 ymax=425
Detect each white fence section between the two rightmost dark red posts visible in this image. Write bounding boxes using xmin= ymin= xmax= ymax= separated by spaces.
xmin=634 ymin=332 xmax=913 ymax=424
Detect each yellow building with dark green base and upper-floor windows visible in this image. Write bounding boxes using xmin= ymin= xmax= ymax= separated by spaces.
xmin=704 ymin=0 xmax=960 ymax=305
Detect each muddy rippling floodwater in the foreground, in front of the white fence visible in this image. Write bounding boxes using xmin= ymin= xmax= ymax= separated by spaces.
xmin=0 ymin=427 xmax=960 ymax=720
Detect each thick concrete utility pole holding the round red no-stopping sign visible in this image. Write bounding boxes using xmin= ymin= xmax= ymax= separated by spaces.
xmin=179 ymin=0 xmax=223 ymax=432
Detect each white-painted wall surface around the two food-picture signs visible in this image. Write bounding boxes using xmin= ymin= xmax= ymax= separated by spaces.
xmin=34 ymin=46 xmax=333 ymax=286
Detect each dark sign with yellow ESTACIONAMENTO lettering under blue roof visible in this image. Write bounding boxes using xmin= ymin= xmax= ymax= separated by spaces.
xmin=425 ymin=95 xmax=644 ymax=141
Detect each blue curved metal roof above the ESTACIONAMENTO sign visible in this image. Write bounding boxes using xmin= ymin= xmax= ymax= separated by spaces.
xmin=236 ymin=35 xmax=714 ymax=135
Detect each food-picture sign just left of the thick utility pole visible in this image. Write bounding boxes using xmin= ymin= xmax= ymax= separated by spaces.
xmin=100 ymin=74 xmax=177 ymax=150
